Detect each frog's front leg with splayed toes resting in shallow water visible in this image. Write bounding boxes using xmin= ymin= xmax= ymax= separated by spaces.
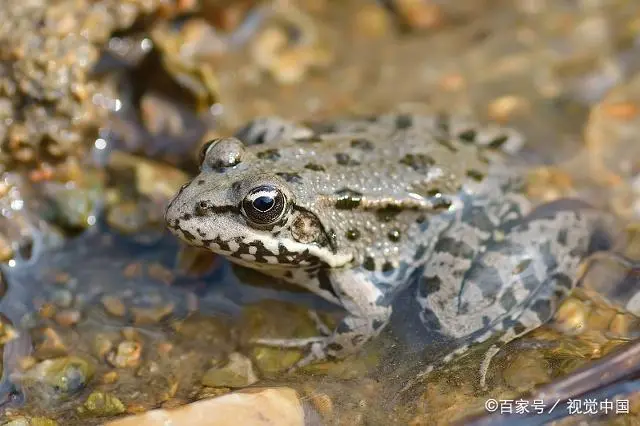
xmin=254 ymin=270 xmax=391 ymax=369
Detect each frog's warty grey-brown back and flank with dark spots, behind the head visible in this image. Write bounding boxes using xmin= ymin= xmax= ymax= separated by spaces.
xmin=240 ymin=114 xmax=520 ymax=279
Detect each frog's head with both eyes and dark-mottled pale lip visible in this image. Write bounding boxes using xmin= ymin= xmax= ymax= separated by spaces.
xmin=165 ymin=138 xmax=352 ymax=272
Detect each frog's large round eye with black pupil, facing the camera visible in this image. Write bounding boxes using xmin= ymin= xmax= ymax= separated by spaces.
xmin=242 ymin=185 xmax=287 ymax=226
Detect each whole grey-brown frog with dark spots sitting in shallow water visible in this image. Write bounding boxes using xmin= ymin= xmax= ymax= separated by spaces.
xmin=165 ymin=112 xmax=636 ymax=385
